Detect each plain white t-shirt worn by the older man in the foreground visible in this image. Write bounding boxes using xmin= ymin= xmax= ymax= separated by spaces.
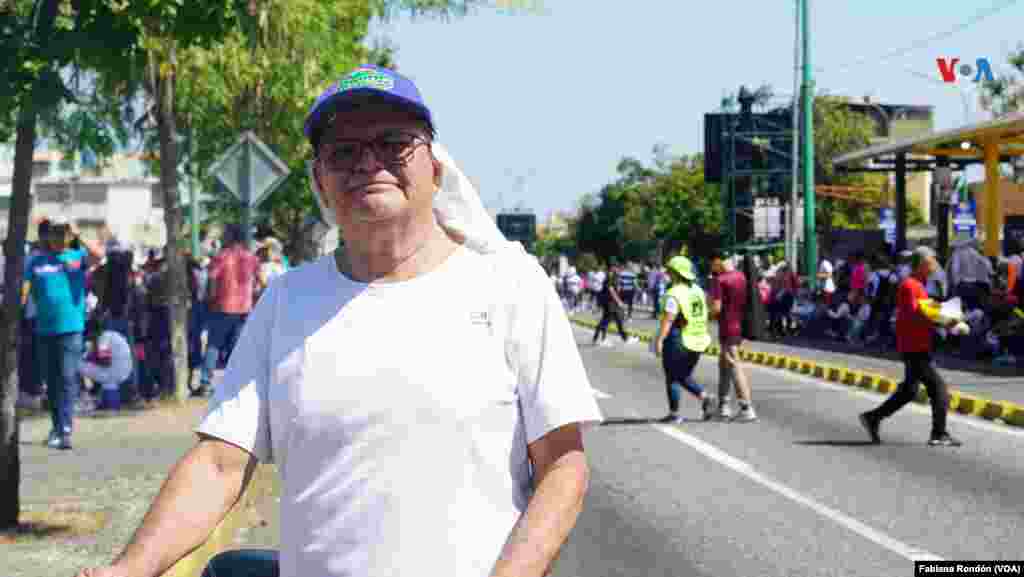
xmin=198 ymin=248 xmax=602 ymax=577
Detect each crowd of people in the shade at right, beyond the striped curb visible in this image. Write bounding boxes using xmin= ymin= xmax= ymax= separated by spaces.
xmin=758 ymin=241 xmax=1024 ymax=365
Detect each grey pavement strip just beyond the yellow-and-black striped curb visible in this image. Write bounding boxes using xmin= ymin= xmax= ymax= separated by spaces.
xmin=570 ymin=307 xmax=1024 ymax=424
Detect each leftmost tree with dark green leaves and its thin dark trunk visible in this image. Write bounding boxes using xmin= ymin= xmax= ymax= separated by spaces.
xmin=0 ymin=0 xmax=240 ymax=527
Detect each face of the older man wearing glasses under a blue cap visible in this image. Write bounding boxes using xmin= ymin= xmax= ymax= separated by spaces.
xmin=315 ymin=102 xmax=440 ymax=229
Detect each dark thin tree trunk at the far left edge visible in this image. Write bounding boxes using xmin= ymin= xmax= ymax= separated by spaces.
xmin=0 ymin=107 xmax=37 ymax=528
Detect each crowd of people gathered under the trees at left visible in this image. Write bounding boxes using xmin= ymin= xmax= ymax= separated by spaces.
xmin=17 ymin=218 xmax=288 ymax=449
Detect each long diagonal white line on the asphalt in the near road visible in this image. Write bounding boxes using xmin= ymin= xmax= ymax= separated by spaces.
xmin=652 ymin=425 xmax=942 ymax=561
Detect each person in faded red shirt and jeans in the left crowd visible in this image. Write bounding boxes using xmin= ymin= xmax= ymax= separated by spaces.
xmin=201 ymin=224 xmax=260 ymax=393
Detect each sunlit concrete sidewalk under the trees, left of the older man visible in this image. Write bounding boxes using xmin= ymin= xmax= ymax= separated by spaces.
xmin=9 ymin=400 xmax=279 ymax=577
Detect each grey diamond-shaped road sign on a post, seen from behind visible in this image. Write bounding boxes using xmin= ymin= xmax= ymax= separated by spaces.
xmin=210 ymin=131 xmax=289 ymax=246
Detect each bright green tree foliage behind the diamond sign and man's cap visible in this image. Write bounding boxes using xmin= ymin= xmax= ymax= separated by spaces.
xmin=176 ymin=0 xmax=382 ymax=256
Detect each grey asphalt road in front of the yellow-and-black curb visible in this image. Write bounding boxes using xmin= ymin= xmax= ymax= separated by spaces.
xmin=555 ymin=328 xmax=1024 ymax=577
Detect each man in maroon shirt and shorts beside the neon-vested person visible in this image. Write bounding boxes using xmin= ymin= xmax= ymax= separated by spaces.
xmin=711 ymin=254 xmax=758 ymax=422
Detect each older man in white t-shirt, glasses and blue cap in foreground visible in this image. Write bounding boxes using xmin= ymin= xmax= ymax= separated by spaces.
xmin=86 ymin=67 xmax=601 ymax=577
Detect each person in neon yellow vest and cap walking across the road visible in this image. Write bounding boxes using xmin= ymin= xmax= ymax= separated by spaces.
xmin=654 ymin=255 xmax=712 ymax=424
